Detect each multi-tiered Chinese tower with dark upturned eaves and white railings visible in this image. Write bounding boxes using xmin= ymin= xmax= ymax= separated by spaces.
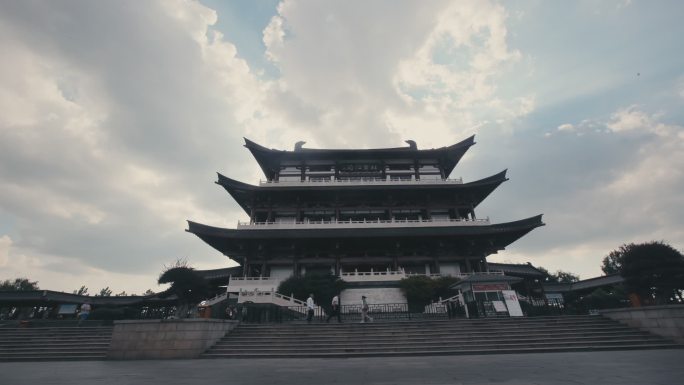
xmin=188 ymin=137 xmax=543 ymax=303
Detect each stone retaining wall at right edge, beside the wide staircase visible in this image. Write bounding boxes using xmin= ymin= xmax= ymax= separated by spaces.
xmin=601 ymin=305 xmax=684 ymax=343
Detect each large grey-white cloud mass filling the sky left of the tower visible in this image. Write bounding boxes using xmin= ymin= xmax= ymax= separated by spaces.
xmin=0 ymin=2 xmax=264 ymax=288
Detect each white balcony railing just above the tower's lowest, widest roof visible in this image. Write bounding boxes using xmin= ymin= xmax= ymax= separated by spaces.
xmin=237 ymin=217 xmax=489 ymax=230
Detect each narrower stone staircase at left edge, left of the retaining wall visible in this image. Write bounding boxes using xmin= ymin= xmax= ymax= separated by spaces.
xmin=0 ymin=326 xmax=112 ymax=362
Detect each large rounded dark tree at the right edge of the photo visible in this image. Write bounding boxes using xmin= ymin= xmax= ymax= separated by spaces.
xmin=616 ymin=241 xmax=684 ymax=304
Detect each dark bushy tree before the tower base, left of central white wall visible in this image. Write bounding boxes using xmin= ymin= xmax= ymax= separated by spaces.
xmin=278 ymin=273 xmax=346 ymax=311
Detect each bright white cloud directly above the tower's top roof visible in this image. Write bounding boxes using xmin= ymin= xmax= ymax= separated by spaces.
xmin=263 ymin=1 xmax=535 ymax=148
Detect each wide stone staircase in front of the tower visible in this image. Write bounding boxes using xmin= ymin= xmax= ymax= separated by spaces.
xmin=201 ymin=316 xmax=684 ymax=358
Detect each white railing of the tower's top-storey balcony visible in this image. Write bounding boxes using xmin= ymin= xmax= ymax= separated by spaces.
xmin=259 ymin=178 xmax=463 ymax=187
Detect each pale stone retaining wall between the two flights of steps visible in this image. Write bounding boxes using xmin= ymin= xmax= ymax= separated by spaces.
xmin=107 ymin=318 xmax=238 ymax=360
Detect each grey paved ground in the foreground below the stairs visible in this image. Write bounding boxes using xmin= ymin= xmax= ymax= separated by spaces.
xmin=0 ymin=349 xmax=684 ymax=385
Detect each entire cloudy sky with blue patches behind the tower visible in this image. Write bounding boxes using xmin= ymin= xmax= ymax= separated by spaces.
xmin=0 ymin=0 xmax=684 ymax=293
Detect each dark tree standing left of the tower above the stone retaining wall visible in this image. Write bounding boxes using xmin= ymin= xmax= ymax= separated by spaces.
xmin=157 ymin=259 xmax=210 ymax=318
